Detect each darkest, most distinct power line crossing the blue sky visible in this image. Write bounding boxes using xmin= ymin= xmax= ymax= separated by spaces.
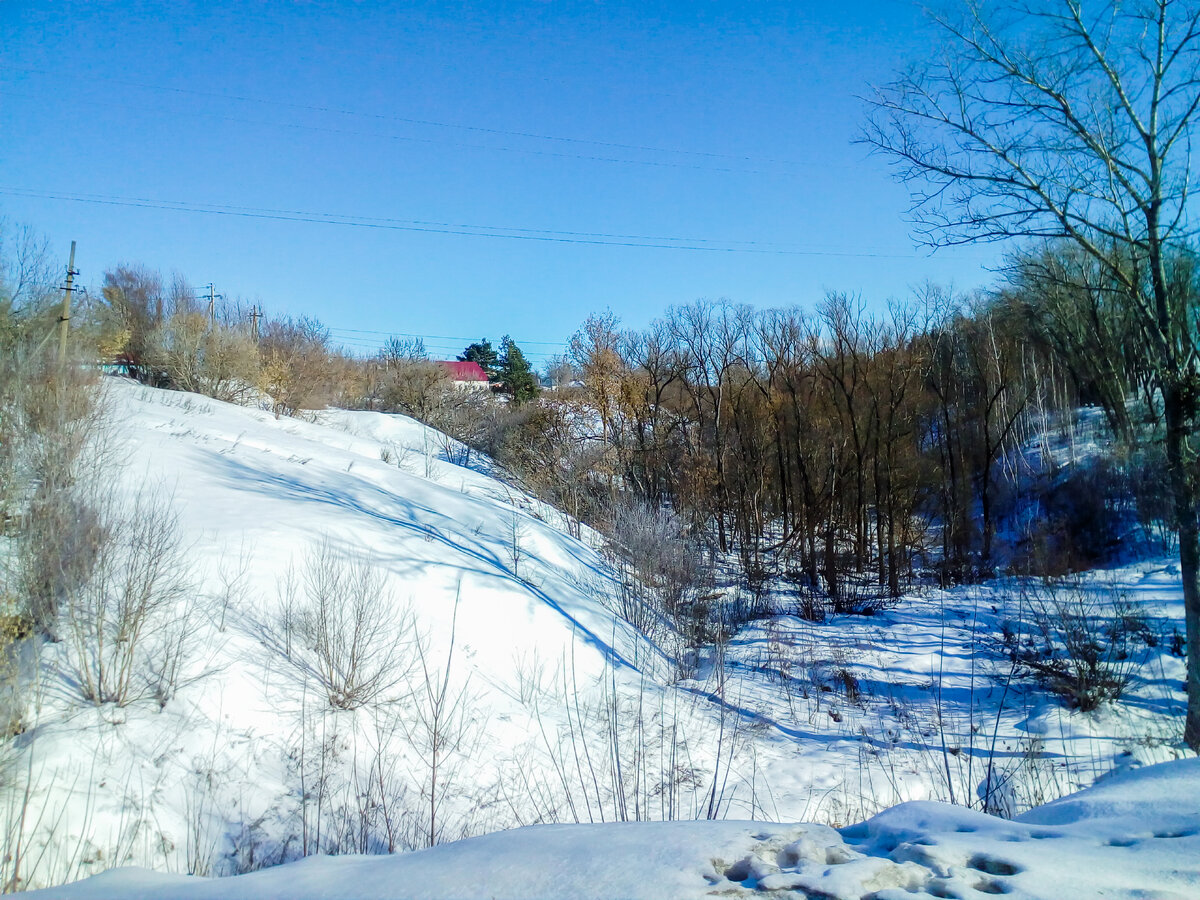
xmin=0 ymin=187 xmax=945 ymax=259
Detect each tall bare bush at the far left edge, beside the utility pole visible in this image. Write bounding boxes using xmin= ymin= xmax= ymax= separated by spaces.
xmin=0 ymin=220 xmax=103 ymax=748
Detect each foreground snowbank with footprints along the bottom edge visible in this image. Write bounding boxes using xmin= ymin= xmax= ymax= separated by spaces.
xmin=25 ymin=760 xmax=1200 ymax=900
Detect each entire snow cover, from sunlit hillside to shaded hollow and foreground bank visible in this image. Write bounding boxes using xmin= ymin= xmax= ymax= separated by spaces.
xmin=6 ymin=379 xmax=1200 ymax=898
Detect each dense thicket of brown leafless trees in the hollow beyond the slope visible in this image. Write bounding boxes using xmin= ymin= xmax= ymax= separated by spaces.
xmin=552 ymin=292 xmax=1171 ymax=611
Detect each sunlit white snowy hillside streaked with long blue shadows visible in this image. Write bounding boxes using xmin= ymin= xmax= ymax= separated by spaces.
xmin=20 ymin=379 xmax=681 ymax=884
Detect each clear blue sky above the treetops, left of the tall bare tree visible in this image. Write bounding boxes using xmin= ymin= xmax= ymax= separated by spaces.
xmin=0 ymin=0 xmax=998 ymax=362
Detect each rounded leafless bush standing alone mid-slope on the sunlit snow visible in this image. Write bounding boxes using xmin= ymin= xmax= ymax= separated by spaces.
xmin=274 ymin=540 xmax=414 ymax=709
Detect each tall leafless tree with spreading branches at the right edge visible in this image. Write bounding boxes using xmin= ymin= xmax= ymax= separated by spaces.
xmin=865 ymin=0 xmax=1200 ymax=749
